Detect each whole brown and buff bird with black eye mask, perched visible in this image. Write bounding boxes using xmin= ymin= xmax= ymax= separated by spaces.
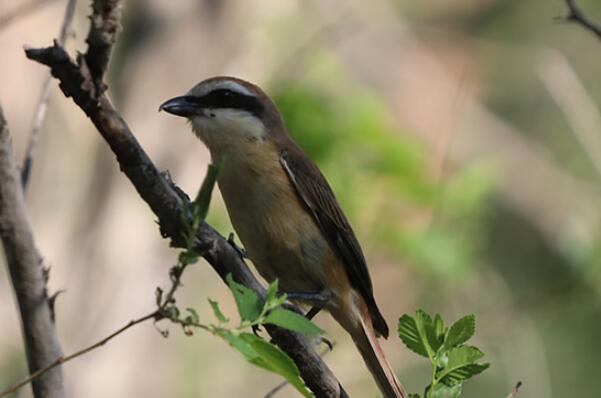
xmin=159 ymin=76 xmax=405 ymax=398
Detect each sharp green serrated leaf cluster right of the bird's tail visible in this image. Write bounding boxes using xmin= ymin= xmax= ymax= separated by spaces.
xmin=398 ymin=310 xmax=490 ymax=398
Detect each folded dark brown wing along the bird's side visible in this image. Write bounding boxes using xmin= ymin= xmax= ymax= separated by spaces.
xmin=280 ymin=144 xmax=388 ymax=337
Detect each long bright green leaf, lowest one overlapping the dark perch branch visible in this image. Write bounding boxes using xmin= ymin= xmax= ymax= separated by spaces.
xmin=239 ymin=333 xmax=312 ymax=398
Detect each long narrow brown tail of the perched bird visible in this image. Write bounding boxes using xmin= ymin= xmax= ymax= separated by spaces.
xmin=332 ymin=300 xmax=406 ymax=398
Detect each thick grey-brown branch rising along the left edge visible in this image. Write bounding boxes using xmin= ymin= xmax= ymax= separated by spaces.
xmin=0 ymin=108 xmax=66 ymax=398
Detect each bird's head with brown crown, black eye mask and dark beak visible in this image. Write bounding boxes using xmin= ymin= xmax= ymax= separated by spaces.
xmin=159 ymin=76 xmax=283 ymax=154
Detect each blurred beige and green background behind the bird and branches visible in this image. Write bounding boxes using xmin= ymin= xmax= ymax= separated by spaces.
xmin=0 ymin=0 xmax=601 ymax=398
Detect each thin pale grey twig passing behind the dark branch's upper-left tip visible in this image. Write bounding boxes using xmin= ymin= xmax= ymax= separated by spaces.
xmin=21 ymin=0 xmax=77 ymax=189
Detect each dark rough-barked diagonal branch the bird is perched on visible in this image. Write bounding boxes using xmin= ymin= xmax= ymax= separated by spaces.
xmin=26 ymin=0 xmax=346 ymax=398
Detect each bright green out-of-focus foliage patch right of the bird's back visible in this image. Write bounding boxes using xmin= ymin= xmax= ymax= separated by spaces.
xmin=272 ymin=54 xmax=495 ymax=278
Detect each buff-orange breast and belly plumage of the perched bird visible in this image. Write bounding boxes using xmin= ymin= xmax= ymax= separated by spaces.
xmin=218 ymin=144 xmax=331 ymax=292
